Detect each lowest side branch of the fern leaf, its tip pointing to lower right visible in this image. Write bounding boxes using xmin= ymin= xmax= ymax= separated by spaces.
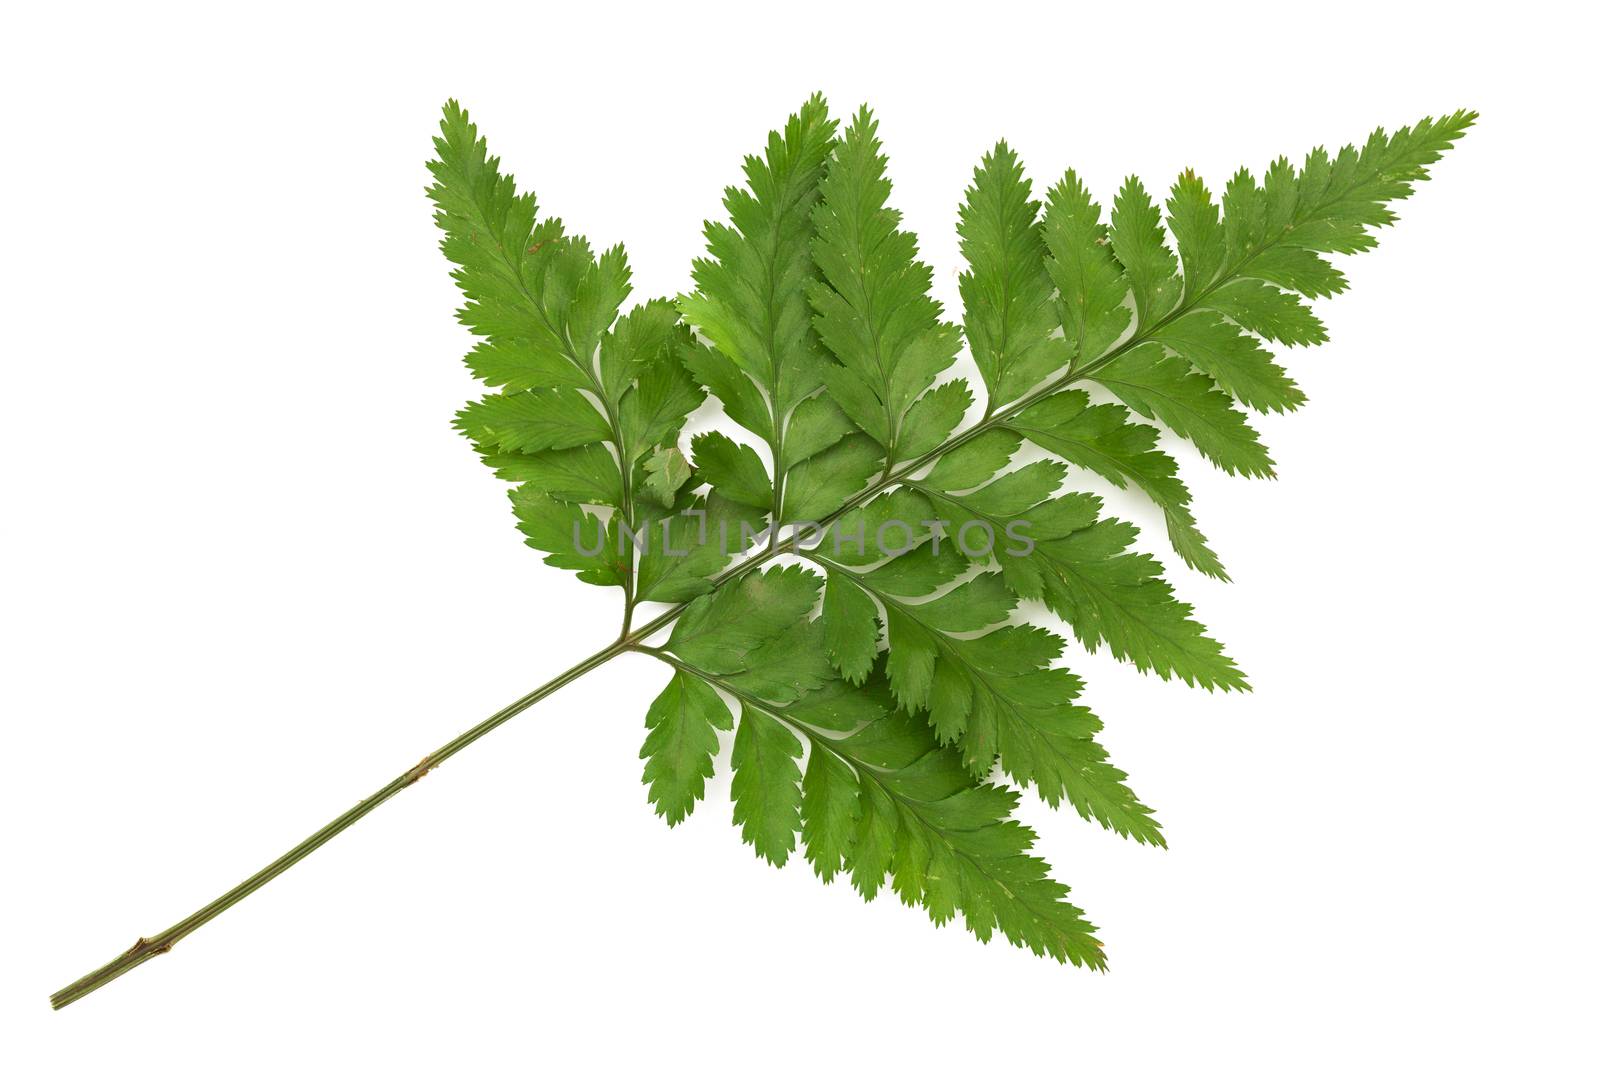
xmin=633 ymin=569 xmax=1100 ymax=968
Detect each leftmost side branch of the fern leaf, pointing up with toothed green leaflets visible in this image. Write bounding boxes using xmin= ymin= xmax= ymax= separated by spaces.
xmin=427 ymin=101 xmax=710 ymax=611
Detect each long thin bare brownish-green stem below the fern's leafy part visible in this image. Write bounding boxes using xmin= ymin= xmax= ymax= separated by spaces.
xmin=50 ymin=639 xmax=630 ymax=1009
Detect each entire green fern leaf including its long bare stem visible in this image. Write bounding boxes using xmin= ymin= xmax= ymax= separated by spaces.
xmin=54 ymin=96 xmax=1475 ymax=1006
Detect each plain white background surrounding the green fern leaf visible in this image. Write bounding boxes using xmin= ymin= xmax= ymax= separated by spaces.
xmin=0 ymin=3 xmax=1600 ymax=1064
